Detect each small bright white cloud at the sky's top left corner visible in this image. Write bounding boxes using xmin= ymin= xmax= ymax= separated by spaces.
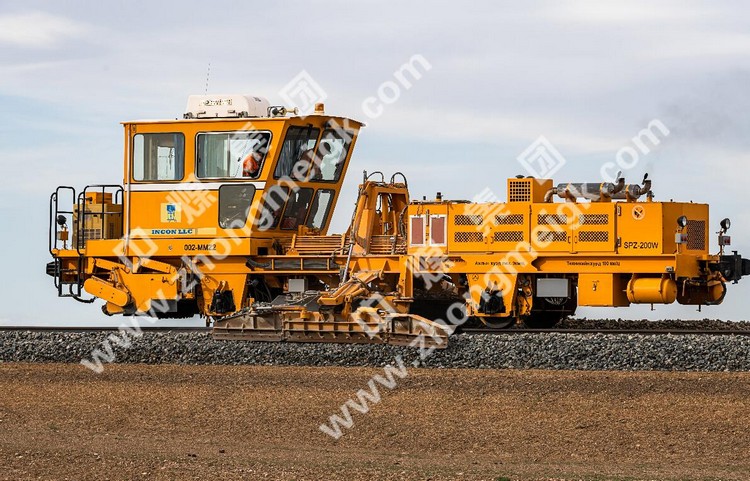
xmin=0 ymin=12 xmax=87 ymax=48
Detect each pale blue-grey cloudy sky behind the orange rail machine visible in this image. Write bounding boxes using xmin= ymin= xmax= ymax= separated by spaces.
xmin=0 ymin=0 xmax=750 ymax=324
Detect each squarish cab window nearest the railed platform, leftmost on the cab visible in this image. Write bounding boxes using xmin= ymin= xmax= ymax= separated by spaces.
xmin=133 ymin=133 xmax=185 ymax=181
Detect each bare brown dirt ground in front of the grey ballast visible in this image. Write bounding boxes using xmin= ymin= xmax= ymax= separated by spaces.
xmin=0 ymin=364 xmax=750 ymax=480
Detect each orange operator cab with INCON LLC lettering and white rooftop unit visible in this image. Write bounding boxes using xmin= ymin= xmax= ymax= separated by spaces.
xmin=124 ymin=95 xmax=362 ymax=255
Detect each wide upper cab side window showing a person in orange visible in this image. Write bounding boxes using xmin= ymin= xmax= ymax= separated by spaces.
xmin=196 ymin=132 xmax=271 ymax=179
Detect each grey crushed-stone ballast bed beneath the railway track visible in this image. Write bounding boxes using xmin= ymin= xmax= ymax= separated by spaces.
xmin=0 ymin=331 xmax=750 ymax=371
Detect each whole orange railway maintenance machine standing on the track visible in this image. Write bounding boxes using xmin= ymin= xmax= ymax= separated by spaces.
xmin=47 ymin=95 xmax=750 ymax=347
